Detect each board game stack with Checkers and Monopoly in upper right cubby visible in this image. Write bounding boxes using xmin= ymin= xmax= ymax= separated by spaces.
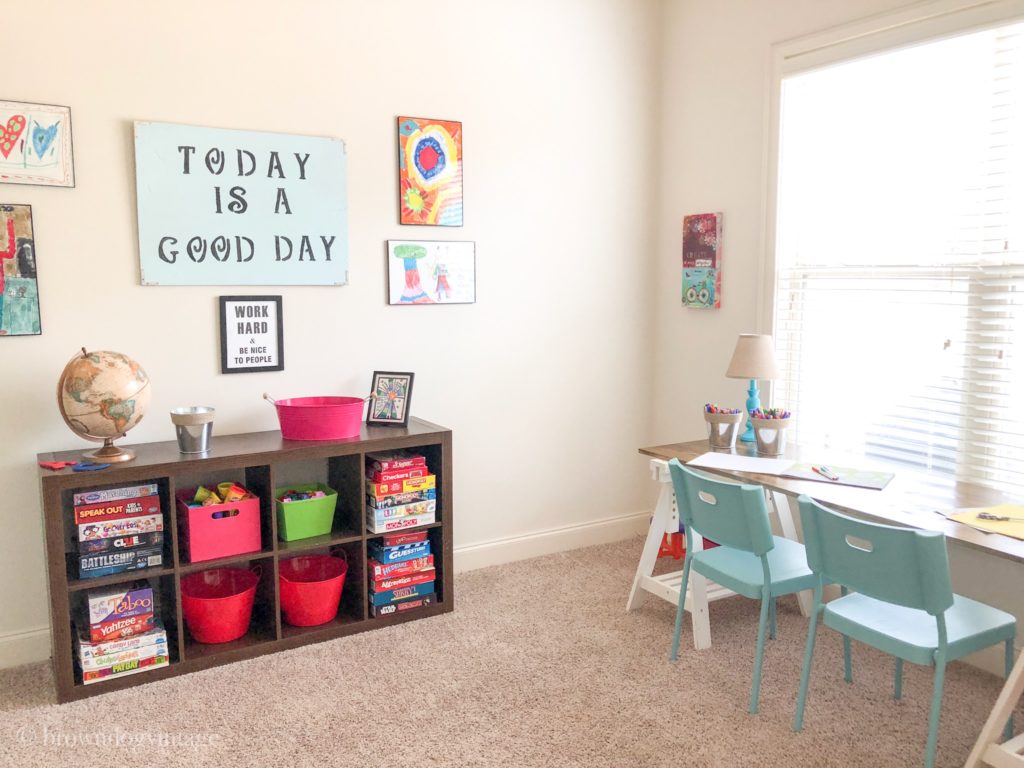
xmin=367 ymin=453 xmax=437 ymax=534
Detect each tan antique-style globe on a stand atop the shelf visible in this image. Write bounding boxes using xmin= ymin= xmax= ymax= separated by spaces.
xmin=57 ymin=347 xmax=153 ymax=462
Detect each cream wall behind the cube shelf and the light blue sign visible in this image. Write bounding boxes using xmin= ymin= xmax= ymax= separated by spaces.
xmin=0 ymin=0 xmax=674 ymax=666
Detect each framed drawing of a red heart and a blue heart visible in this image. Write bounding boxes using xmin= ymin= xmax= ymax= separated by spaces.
xmin=0 ymin=101 xmax=75 ymax=186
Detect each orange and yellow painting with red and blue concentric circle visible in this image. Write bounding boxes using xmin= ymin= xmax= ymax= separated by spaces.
xmin=398 ymin=118 xmax=462 ymax=226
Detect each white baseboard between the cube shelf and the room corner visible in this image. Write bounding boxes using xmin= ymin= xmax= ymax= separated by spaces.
xmin=455 ymin=510 xmax=650 ymax=573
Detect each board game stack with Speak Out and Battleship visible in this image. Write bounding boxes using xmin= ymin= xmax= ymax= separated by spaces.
xmin=74 ymin=483 xmax=164 ymax=579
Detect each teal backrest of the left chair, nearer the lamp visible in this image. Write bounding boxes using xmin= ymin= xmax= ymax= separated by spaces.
xmin=669 ymin=459 xmax=775 ymax=555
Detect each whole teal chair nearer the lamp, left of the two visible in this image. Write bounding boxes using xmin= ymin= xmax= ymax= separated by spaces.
xmin=669 ymin=459 xmax=816 ymax=713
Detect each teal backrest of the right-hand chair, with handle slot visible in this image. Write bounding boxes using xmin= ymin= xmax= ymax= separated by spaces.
xmin=799 ymin=496 xmax=953 ymax=615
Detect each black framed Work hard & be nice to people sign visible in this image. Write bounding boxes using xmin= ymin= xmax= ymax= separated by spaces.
xmin=220 ymin=296 xmax=285 ymax=374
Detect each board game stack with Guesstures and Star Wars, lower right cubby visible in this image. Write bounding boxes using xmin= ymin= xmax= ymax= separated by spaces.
xmin=367 ymin=530 xmax=437 ymax=616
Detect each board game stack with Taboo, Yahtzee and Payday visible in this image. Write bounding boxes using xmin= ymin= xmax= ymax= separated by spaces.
xmin=75 ymin=584 xmax=169 ymax=685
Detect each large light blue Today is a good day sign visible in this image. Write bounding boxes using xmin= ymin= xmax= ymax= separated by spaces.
xmin=135 ymin=123 xmax=348 ymax=286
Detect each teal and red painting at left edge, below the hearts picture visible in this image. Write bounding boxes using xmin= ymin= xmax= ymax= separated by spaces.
xmin=0 ymin=205 xmax=42 ymax=336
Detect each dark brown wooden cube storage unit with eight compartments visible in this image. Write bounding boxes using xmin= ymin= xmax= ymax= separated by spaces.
xmin=38 ymin=419 xmax=455 ymax=702
